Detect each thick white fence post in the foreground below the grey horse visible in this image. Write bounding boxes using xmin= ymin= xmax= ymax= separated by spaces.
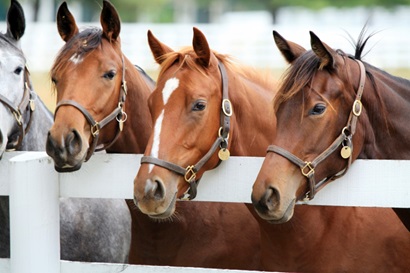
xmin=9 ymin=152 xmax=60 ymax=273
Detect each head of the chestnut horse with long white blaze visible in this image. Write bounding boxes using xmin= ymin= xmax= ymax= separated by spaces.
xmin=134 ymin=28 xmax=232 ymax=218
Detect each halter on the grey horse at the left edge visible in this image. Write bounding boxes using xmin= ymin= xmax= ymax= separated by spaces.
xmin=0 ymin=67 xmax=37 ymax=151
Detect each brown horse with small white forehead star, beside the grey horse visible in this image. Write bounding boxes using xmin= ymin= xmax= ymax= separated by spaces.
xmin=47 ymin=1 xmax=260 ymax=269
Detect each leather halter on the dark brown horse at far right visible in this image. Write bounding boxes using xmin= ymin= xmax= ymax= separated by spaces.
xmin=267 ymin=60 xmax=366 ymax=201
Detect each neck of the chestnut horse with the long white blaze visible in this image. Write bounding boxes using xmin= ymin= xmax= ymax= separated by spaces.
xmin=228 ymin=71 xmax=277 ymax=156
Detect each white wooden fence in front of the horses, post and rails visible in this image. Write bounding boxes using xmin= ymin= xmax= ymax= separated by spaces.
xmin=0 ymin=152 xmax=410 ymax=273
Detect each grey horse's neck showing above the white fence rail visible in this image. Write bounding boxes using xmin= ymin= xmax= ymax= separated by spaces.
xmin=19 ymin=96 xmax=54 ymax=151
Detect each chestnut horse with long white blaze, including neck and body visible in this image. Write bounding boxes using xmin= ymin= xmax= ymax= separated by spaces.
xmin=134 ymin=26 xmax=394 ymax=272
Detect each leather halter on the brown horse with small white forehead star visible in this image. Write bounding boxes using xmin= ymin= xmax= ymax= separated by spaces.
xmin=54 ymin=56 xmax=127 ymax=161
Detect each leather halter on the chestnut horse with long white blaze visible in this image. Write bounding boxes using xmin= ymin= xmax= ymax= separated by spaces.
xmin=141 ymin=62 xmax=232 ymax=200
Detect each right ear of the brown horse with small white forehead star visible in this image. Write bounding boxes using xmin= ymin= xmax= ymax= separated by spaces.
xmin=100 ymin=0 xmax=121 ymax=42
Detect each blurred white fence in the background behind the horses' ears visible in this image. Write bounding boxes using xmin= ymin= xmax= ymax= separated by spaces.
xmin=0 ymin=21 xmax=410 ymax=71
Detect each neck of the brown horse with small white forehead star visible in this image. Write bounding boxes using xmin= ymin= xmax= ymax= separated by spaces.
xmin=107 ymin=58 xmax=154 ymax=153
